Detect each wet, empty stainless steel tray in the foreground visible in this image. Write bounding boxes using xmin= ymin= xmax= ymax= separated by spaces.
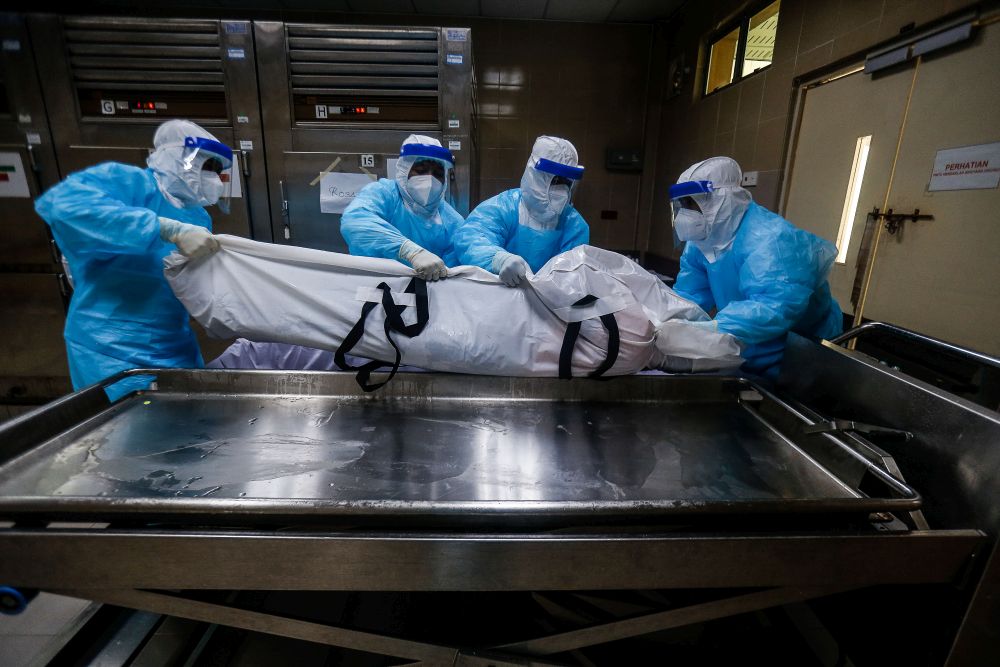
xmin=0 ymin=370 xmax=920 ymax=526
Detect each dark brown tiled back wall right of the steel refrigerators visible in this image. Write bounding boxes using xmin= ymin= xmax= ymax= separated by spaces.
xmin=466 ymin=20 xmax=653 ymax=250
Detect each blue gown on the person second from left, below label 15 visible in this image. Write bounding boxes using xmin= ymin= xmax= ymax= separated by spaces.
xmin=340 ymin=178 xmax=462 ymax=267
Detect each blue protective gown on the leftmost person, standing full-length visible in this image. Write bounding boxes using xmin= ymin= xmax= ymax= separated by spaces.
xmin=35 ymin=162 xmax=212 ymax=400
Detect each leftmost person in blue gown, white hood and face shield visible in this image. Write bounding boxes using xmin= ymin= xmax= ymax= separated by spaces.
xmin=35 ymin=120 xmax=233 ymax=400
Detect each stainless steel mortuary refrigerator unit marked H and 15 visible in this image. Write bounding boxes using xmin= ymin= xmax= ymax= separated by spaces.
xmin=254 ymin=21 xmax=478 ymax=252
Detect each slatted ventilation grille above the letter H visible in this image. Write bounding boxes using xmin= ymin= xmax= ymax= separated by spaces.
xmin=287 ymin=24 xmax=438 ymax=97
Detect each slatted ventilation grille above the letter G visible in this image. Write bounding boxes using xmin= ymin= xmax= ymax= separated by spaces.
xmin=63 ymin=18 xmax=224 ymax=92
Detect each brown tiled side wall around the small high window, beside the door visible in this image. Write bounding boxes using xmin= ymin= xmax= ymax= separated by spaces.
xmin=647 ymin=0 xmax=970 ymax=257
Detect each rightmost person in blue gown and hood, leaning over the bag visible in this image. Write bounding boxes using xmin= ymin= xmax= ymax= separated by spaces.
xmin=670 ymin=157 xmax=843 ymax=377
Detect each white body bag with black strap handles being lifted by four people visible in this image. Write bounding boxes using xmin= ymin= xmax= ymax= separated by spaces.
xmin=164 ymin=235 xmax=742 ymax=389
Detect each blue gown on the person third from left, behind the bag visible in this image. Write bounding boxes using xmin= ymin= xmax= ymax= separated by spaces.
xmin=455 ymin=188 xmax=590 ymax=273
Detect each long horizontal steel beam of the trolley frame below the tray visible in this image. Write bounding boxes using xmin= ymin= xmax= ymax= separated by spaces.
xmin=0 ymin=525 xmax=987 ymax=591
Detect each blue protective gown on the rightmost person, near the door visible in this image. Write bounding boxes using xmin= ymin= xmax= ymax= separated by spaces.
xmin=674 ymin=202 xmax=844 ymax=377
